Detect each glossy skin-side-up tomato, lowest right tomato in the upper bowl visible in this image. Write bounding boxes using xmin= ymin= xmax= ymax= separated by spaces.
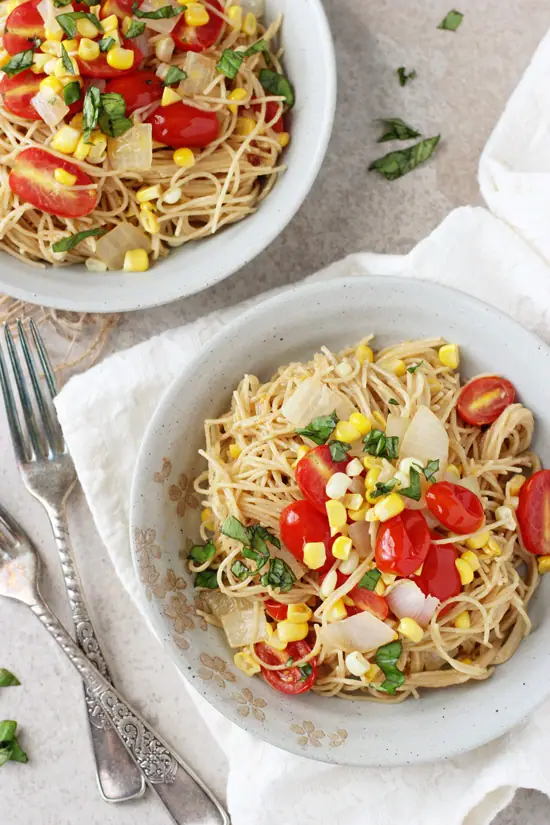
xmin=146 ymin=102 xmax=219 ymax=149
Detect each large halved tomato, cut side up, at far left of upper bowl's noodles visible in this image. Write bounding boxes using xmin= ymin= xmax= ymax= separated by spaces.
xmin=8 ymin=147 xmax=97 ymax=218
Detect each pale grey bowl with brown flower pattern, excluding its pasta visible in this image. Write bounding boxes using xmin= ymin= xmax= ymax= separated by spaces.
xmin=131 ymin=277 xmax=550 ymax=766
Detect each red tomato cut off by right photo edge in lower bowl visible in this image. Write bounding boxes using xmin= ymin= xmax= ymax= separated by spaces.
xmin=517 ymin=470 xmax=550 ymax=556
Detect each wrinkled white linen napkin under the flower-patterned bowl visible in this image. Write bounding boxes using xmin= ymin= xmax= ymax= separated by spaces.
xmin=56 ymin=29 xmax=550 ymax=825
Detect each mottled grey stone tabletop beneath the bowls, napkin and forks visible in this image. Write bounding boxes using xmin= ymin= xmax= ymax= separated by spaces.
xmin=0 ymin=0 xmax=550 ymax=825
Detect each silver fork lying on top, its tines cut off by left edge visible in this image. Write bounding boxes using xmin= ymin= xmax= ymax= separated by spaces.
xmin=0 ymin=506 xmax=230 ymax=825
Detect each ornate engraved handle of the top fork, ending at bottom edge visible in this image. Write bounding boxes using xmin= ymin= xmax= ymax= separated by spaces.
xmin=31 ymin=600 xmax=230 ymax=825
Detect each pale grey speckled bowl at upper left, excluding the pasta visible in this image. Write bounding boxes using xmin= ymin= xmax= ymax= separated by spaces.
xmin=0 ymin=0 xmax=336 ymax=312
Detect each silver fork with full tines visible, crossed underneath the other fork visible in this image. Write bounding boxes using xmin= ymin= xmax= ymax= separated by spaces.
xmin=0 ymin=321 xmax=146 ymax=802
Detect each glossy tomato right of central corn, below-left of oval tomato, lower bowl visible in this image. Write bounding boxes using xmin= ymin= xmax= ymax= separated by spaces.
xmin=374 ymin=510 xmax=430 ymax=576
